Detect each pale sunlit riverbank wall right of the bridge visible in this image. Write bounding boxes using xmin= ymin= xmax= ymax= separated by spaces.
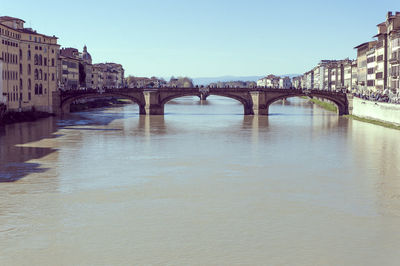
xmin=351 ymin=97 xmax=400 ymax=125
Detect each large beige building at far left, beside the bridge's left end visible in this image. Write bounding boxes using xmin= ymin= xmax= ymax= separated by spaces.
xmin=0 ymin=16 xmax=60 ymax=112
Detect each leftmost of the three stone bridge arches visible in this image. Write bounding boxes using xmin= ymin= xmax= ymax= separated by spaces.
xmin=60 ymin=92 xmax=145 ymax=114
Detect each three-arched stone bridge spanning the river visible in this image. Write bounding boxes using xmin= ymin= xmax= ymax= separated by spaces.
xmin=53 ymin=87 xmax=352 ymax=115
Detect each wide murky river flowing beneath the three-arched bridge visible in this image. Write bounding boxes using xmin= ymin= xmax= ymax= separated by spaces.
xmin=0 ymin=96 xmax=400 ymax=265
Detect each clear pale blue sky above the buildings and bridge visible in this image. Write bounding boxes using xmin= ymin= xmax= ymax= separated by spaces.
xmin=0 ymin=0 xmax=400 ymax=77
